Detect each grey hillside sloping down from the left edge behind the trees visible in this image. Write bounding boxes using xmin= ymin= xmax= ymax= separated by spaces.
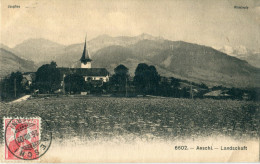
xmin=0 ymin=48 xmax=37 ymax=78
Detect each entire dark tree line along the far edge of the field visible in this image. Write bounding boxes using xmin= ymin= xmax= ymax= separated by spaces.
xmin=1 ymin=62 xmax=257 ymax=100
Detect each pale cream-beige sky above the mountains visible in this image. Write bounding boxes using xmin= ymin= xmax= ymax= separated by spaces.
xmin=0 ymin=0 xmax=260 ymax=51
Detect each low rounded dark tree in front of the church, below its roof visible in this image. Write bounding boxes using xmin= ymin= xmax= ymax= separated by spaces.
xmin=64 ymin=74 xmax=85 ymax=93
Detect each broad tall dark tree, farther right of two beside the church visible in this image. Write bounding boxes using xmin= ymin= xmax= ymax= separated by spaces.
xmin=134 ymin=63 xmax=160 ymax=95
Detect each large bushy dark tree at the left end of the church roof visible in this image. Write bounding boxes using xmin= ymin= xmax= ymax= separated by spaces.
xmin=36 ymin=61 xmax=61 ymax=92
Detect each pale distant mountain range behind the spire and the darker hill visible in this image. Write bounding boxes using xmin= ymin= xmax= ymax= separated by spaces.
xmin=10 ymin=33 xmax=260 ymax=68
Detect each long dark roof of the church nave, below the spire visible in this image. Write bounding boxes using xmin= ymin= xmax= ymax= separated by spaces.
xmin=58 ymin=68 xmax=109 ymax=76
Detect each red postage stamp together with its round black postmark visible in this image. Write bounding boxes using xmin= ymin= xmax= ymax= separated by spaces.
xmin=4 ymin=117 xmax=52 ymax=161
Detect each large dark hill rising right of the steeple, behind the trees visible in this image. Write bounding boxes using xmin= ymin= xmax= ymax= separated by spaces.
xmin=93 ymin=40 xmax=260 ymax=87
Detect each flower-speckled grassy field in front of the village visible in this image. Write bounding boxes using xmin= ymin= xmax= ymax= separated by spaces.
xmin=0 ymin=97 xmax=260 ymax=141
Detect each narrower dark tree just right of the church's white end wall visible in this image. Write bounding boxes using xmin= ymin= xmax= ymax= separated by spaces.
xmin=110 ymin=64 xmax=129 ymax=92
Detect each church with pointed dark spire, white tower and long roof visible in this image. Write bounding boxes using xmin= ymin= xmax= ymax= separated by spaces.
xmin=58 ymin=38 xmax=109 ymax=83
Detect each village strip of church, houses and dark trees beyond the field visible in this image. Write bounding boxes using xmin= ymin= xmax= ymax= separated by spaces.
xmin=1 ymin=38 xmax=256 ymax=100
